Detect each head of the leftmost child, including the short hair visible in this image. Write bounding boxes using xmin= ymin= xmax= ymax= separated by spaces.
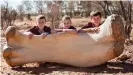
xmin=36 ymin=15 xmax=46 ymax=27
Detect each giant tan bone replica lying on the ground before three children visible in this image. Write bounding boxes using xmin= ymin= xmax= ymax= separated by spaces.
xmin=3 ymin=14 xmax=125 ymax=67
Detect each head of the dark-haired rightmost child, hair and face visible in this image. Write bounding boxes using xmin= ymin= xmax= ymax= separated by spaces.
xmin=90 ymin=10 xmax=102 ymax=24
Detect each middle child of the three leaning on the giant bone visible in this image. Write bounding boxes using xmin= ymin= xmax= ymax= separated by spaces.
xmin=55 ymin=16 xmax=76 ymax=33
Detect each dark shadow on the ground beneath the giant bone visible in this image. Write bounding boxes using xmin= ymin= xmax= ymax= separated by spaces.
xmin=12 ymin=62 xmax=133 ymax=74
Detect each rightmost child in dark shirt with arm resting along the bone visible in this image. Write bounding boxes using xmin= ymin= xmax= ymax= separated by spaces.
xmin=78 ymin=10 xmax=101 ymax=32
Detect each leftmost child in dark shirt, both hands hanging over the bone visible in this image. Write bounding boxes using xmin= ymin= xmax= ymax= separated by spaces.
xmin=28 ymin=15 xmax=51 ymax=39
